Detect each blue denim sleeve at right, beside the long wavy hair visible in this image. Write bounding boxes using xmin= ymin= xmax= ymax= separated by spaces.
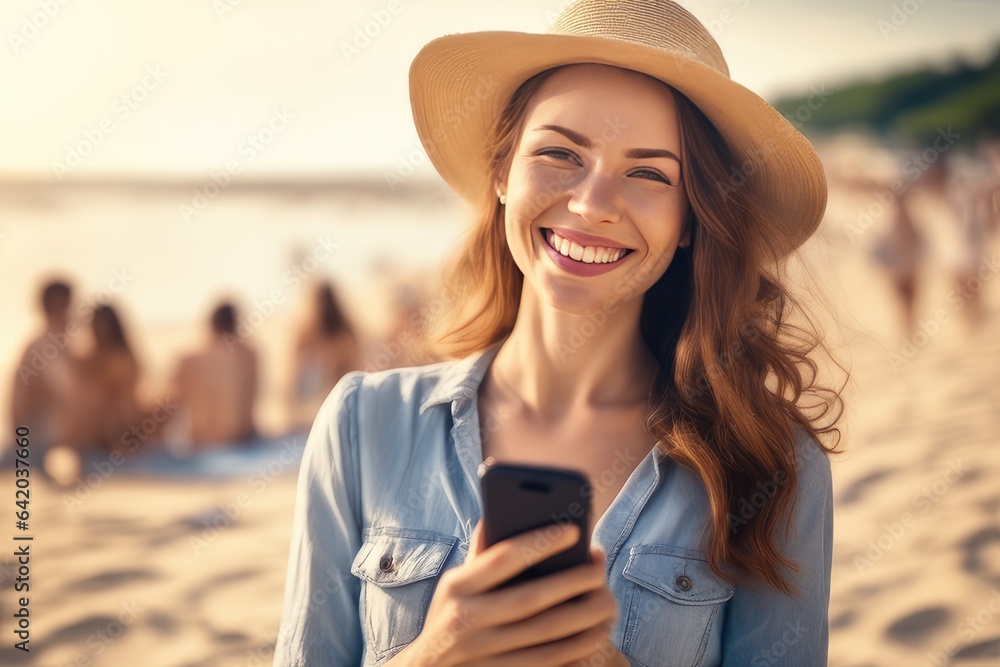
xmin=722 ymin=429 xmax=833 ymax=667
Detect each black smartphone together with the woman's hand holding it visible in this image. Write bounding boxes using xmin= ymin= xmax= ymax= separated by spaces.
xmin=387 ymin=459 xmax=627 ymax=667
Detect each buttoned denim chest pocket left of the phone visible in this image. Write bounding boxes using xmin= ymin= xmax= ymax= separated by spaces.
xmin=351 ymin=527 xmax=458 ymax=665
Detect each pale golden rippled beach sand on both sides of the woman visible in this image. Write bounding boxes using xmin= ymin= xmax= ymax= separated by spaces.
xmin=0 ymin=175 xmax=1000 ymax=667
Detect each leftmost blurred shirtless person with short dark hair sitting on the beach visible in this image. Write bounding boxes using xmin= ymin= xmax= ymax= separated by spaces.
xmin=11 ymin=279 xmax=79 ymax=460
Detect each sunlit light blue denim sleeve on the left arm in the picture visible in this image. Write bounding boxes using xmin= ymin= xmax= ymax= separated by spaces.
xmin=274 ymin=371 xmax=364 ymax=667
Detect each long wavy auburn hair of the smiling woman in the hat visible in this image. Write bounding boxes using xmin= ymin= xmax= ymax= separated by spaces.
xmin=426 ymin=67 xmax=846 ymax=594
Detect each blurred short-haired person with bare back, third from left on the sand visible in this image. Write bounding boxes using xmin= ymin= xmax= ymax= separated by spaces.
xmin=171 ymin=303 xmax=258 ymax=450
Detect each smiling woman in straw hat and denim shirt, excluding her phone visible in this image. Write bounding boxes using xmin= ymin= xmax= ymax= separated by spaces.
xmin=275 ymin=0 xmax=839 ymax=667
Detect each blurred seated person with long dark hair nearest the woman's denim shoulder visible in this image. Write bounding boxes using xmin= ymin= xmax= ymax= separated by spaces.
xmin=289 ymin=282 xmax=361 ymax=429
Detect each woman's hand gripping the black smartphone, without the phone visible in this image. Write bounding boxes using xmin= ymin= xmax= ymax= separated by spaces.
xmin=386 ymin=520 xmax=616 ymax=667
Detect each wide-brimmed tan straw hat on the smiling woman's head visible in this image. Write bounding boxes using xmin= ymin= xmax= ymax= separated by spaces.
xmin=410 ymin=0 xmax=826 ymax=254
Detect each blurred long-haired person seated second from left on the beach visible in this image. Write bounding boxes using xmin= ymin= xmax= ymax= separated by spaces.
xmin=70 ymin=305 xmax=148 ymax=452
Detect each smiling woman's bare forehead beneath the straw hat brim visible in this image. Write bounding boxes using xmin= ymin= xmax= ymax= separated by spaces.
xmin=525 ymin=63 xmax=680 ymax=148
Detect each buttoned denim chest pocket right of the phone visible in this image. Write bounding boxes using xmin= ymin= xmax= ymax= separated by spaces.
xmin=622 ymin=544 xmax=735 ymax=667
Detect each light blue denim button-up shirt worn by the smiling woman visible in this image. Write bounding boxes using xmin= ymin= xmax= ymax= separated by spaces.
xmin=274 ymin=341 xmax=833 ymax=667
